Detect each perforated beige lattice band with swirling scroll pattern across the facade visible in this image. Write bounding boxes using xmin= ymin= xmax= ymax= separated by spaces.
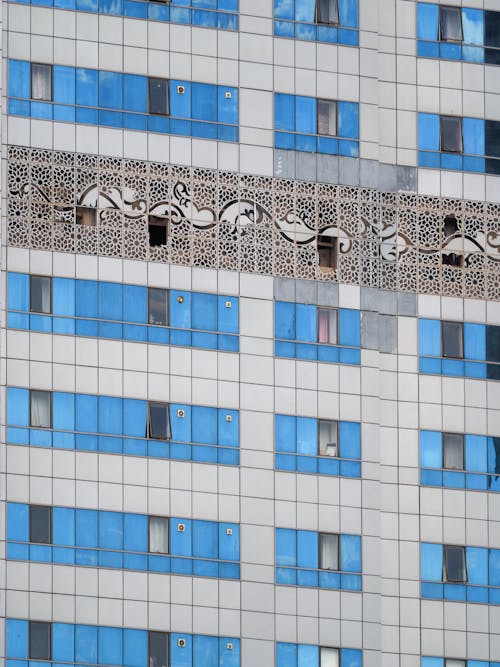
xmin=8 ymin=146 xmax=500 ymax=300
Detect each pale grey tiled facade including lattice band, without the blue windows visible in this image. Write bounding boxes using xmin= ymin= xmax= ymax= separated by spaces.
xmin=0 ymin=0 xmax=500 ymax=667
